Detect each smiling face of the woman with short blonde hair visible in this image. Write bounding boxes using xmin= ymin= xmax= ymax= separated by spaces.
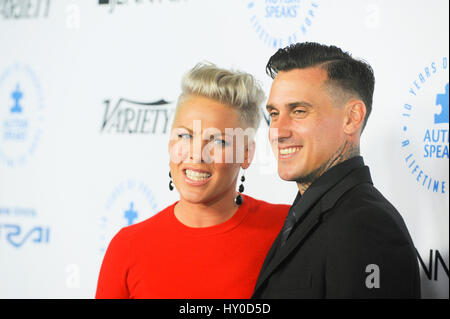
xmin=169 ymin=96 xmax=253 ymax=203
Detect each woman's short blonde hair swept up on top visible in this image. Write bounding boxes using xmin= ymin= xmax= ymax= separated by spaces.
xmin=177 ymin=62 xmax=265 ymax=130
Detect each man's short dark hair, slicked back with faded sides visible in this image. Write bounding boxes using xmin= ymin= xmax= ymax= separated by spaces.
xmin=266 ymin=42 xmax=375 ymax=129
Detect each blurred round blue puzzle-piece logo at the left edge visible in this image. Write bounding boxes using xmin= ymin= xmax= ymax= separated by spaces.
xmin=0 ymin=64 xmax=44 ymax=167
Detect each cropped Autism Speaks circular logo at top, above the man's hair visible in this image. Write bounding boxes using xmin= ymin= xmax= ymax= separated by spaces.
xmin=247 ymin=0 xmax=319 ymax=49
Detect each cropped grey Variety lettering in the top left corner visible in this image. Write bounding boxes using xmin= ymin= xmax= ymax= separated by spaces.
xmin=0 ymin=0 xmax=50 ymax=20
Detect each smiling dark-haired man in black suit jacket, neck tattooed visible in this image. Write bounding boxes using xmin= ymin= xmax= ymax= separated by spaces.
xmin=253 ymin=43 xmax=420 ymax=298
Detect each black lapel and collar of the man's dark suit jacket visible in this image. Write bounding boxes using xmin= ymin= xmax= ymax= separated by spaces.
xmin=255 ymin=166 xmax=372 ymax=292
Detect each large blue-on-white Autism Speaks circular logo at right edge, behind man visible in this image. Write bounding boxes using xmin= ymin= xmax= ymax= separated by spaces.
xmin=401 ymin=57 xmax=449 ymax=195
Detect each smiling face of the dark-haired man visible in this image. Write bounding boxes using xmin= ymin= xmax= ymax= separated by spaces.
xmin=267 ymin=67 xmax=345 ymax=182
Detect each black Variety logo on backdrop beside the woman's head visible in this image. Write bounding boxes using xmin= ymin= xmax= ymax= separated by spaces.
xmin=100 ymin=98 xmax=175 ymax=134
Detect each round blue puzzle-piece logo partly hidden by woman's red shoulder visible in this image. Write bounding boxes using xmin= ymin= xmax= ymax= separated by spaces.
xmin=100 ymin=180 xmax=158 ymax=253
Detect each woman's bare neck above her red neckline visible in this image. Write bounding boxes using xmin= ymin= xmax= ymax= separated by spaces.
xmin=174 ymin=189 xmax=239 ymax=227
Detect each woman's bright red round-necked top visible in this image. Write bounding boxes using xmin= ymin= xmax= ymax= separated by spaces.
xmin=96 ymin=196 xmax=289 ymax=299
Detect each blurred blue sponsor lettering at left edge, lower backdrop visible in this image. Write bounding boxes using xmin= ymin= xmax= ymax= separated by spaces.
xmin=0 ymin=207 xmax=50 ymax=248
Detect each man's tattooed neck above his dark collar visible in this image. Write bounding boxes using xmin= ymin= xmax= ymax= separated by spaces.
xmin=297 ymin=141 xmax=359 ymax=195
